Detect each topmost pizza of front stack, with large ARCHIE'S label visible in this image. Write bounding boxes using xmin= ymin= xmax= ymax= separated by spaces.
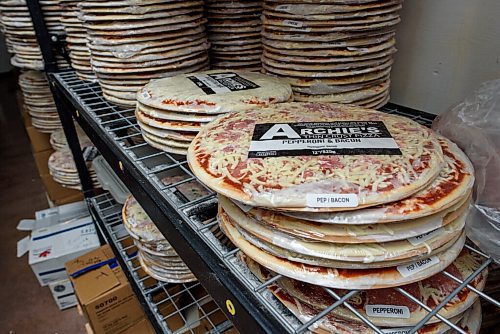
xmin=188 ymin=103 xmax=444 ymax=211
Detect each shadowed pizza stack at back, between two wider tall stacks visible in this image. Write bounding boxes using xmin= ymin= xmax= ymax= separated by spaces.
xmin=206 ymin=0 xmax=262 ymax=71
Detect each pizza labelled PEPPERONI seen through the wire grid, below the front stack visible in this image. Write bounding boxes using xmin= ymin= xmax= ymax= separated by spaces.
xmin=240 ymin=250 xmax=487 ymax=326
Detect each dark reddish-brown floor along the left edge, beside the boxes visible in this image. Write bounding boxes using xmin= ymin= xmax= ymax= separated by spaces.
xmin=0 ymin=73 xmax=85 ymax=334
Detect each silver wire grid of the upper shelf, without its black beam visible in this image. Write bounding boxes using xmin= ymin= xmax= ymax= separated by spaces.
xmin=55 ymin=71 xmax=500 ymax=334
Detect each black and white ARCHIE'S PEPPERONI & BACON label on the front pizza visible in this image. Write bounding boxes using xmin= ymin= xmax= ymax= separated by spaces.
xmin=248 ymin=121 xmax=401 ymax=158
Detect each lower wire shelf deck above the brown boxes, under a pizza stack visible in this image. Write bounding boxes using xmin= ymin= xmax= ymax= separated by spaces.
xmin=90 ymin=193 xmax=233 ymax=334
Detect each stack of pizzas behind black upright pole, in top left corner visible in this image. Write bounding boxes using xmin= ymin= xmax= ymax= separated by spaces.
xmin=0 ymin=0 xmax=68 ymax=70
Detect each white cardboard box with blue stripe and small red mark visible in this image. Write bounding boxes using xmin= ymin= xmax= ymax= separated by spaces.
xmin=28 ymin=217 xmax=100 ymax=286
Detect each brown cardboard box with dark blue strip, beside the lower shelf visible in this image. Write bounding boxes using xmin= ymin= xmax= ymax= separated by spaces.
xmin=66 ymin=245 xmax=145 ymax=334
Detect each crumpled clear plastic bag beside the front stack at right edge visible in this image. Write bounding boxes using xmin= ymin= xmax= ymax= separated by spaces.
xmin=433 ymin=80 xmax=500 ymax=262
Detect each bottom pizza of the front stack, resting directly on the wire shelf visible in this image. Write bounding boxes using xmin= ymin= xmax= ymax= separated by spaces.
xmin=219 ymin=209 xmax=465 ymax=290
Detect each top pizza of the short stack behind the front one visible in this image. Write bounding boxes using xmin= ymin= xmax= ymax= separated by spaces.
xmin=137 ymin=70 xmax=292 ymax=114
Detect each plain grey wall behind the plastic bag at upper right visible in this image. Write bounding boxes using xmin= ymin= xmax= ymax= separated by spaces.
xmin=391 ymin=0 xmax=500 ymax=114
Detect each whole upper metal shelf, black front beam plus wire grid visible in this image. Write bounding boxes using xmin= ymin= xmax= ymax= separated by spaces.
xmin=52 ymin=71 xmax=500 ymax=333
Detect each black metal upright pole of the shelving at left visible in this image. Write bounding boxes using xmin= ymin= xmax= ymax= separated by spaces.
xmin=26 ymin=0 xmax=94 ymax=198
